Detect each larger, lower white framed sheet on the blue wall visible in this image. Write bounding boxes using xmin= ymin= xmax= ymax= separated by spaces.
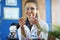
xmin=4 ymin=7 xmax=19 ymax=19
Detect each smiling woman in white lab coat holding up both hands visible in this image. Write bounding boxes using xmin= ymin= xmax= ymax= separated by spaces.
xmin=18 ymin=0 xmax=48 ymax=40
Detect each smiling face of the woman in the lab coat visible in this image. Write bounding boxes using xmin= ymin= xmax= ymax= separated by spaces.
xmin=25 ymin=2 xmax=37 ymax=18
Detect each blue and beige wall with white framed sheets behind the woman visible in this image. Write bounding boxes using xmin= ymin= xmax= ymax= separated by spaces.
xmin=0 ymin=0 xmax=60 ymax=40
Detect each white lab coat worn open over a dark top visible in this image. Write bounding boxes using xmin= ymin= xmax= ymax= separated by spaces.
xmin=18 ymin=20 xmax=48 ymax=40
